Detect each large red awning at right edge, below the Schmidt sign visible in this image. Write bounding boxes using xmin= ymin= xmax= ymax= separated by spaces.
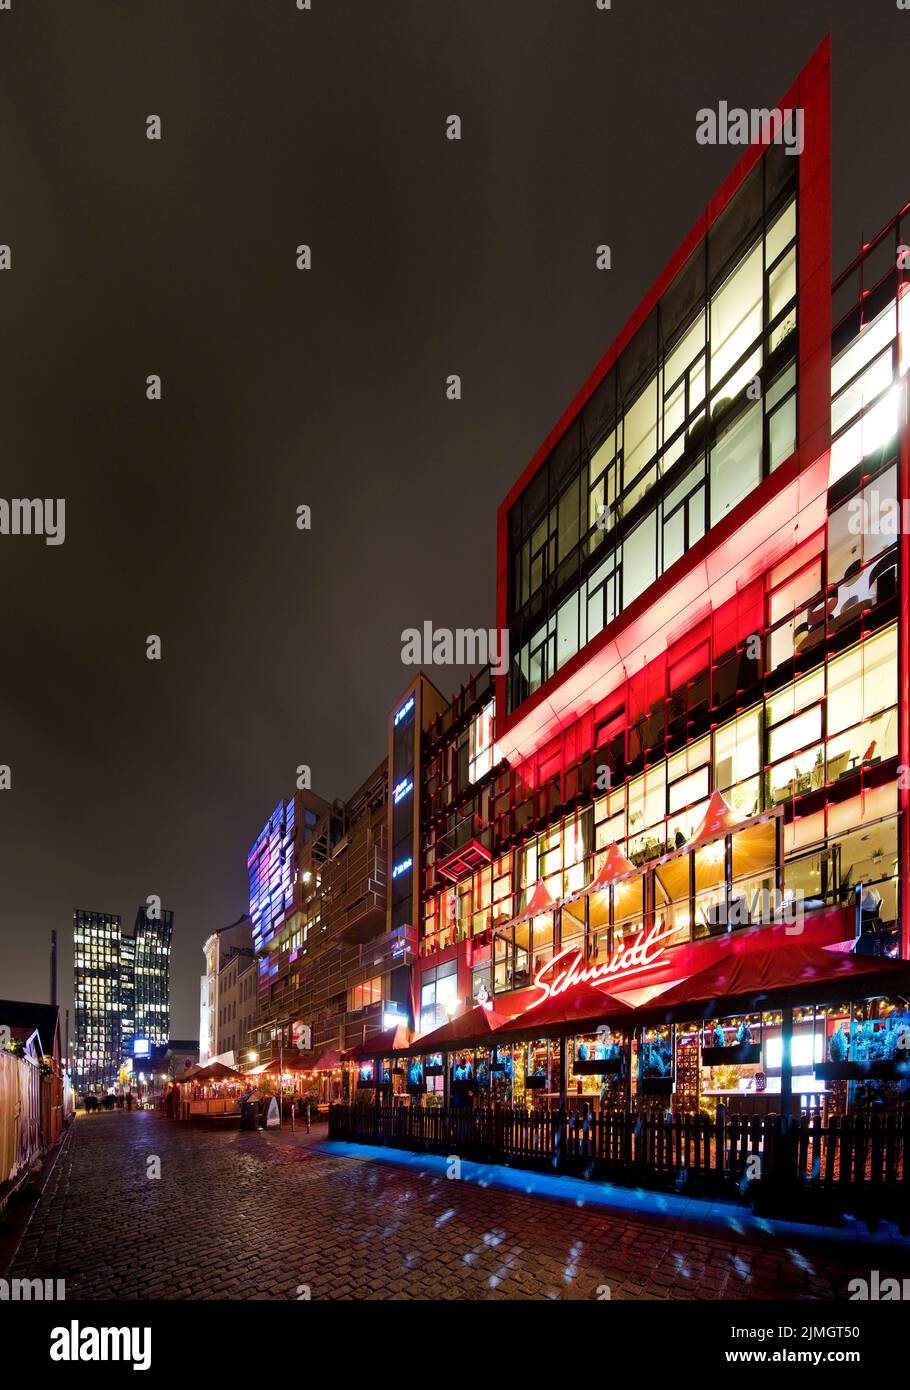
xmin=649 ymin=940 xmax=910 ymax=1012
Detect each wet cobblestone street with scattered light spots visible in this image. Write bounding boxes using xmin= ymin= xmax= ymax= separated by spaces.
xmin=11 ymin=1112 xmax=910 ymax=1300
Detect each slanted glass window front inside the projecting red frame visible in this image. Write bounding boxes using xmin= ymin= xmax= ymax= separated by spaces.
xmin=507 ymin=149 xmax=799 ymax=710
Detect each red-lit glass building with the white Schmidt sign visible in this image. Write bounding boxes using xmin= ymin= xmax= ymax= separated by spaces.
xmin=415 ymin=44 xmax=910 ymax=1112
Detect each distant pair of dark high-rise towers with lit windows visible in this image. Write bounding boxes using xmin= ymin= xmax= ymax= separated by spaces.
xmin=72 ymin=905 xmax=174 ymax=1091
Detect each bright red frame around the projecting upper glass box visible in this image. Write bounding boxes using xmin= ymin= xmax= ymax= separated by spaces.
xmin=495 ymin=38 xmax=831 ymax=762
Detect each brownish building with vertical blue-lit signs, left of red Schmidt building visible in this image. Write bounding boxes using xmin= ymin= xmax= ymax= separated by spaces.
xmin=249 ymin=676 xmax=446 ymax=1078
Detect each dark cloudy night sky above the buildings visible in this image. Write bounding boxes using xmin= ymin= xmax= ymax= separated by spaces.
xmin=0 ymin=0 xmax=910 ymax=1037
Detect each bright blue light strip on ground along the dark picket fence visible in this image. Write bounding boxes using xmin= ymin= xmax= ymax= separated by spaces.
xmin=313 ymin=1140 xmax=910 ymax=1255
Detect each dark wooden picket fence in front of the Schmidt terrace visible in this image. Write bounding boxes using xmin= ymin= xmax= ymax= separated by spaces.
xmin=329 ymin=1105 xmax=910 ymax=1218
